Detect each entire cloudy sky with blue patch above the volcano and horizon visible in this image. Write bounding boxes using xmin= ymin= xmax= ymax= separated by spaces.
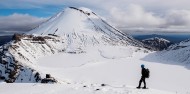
xmin=0 ymin=0 xmax=190 ymax=34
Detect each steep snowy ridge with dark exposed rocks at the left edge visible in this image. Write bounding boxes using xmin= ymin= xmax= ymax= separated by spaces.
xmin=0 ymin=35 xmax=62 ymax=83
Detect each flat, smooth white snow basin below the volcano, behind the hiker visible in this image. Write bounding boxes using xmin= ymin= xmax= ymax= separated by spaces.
xmin=33 ymin=46 xmax=190 ymax=94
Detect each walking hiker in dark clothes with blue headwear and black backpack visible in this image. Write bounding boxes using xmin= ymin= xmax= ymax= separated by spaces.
xmin=137 ymin=64 xmax=149 ymax=89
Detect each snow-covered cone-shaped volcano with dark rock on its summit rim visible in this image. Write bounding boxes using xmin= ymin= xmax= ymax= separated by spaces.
xmin=28 ymin=7 xmax=143 ymax=46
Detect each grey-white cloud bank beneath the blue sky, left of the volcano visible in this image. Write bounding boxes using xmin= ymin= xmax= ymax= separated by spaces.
xmin=0 ymin=13 xmax=47 ymax=33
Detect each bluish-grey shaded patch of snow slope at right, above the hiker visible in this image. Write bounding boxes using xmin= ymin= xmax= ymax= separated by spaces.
xmin=140 ymin=51 xmax=190 ymax=70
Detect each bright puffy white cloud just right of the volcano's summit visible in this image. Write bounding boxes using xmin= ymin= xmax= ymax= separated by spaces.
xmin=110 ymin=4 xmax=165 ymax=28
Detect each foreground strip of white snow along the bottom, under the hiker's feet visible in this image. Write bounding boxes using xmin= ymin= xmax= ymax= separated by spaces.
xmin=0 ymin=84 xmax=174 ymax=94
